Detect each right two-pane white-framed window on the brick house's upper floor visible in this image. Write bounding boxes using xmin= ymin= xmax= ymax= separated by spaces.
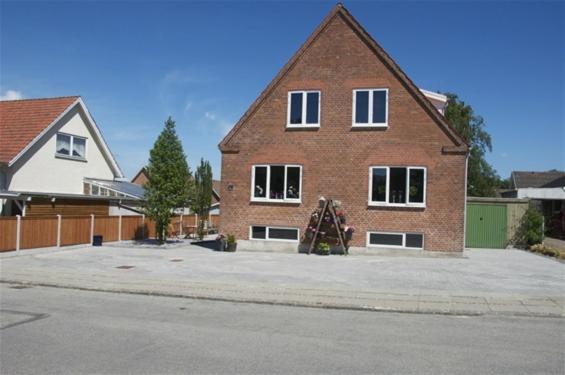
xmin=353 ymin=89 xmax=388 ymax=127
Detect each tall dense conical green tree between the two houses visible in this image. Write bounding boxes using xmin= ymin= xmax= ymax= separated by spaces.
xmin=144 ymin=117 xmax=191 ymax=243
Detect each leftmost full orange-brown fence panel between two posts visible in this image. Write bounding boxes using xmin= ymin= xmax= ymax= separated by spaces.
xmin=20 ymin=216 xmax=57 ymax=249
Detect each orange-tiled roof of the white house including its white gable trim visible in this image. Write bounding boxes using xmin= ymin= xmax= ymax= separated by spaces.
xmin=0 ymin=96 xmax=123 ymax=178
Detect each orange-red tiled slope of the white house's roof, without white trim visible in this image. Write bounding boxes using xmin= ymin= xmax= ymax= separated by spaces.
xmin=0 ymin=96 xmax=79 ymax=164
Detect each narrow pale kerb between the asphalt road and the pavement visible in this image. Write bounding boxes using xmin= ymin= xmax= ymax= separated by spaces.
xmin=0 ymin=279 xmax=565 ymax=319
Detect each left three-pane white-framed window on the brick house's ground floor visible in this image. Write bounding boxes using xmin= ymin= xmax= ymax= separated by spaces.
xmin=251 ymin=165 xmax=302 ymax=202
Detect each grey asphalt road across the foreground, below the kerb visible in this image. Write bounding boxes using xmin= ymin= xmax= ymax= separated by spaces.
xmin=0 ymin=284 xmax=565 ymax=375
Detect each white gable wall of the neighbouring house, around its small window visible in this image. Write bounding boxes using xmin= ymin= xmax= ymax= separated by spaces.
xmin=7 ymin=107 xmax=114 ymax=194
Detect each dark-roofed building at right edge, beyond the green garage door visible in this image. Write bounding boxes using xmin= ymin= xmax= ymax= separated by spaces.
xmin=501 ymin=171 xmax=565 ymax=238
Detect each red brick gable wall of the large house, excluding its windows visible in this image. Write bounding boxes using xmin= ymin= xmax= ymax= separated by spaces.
xmin=220 ymin=16 xmax=465 ymax=251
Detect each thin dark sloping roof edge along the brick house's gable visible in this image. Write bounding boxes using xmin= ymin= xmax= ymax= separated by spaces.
xmin=218 ymin=3 xmax=468 ymax=152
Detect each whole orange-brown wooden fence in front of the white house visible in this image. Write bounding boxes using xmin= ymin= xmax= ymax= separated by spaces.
xmin=0 ymin=215 xmax=220 ymax=252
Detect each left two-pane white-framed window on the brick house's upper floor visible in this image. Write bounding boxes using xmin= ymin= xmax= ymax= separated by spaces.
xmin=287 ymin=91 xmax=320 ymax=128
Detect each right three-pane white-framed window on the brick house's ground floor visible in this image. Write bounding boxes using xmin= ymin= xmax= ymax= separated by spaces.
xmin=369 ymin=167 xmax=426 ymax=207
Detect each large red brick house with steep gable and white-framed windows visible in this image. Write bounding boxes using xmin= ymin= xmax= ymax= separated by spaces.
xmin=219 ymin=4 xmax=468 ymax=251
